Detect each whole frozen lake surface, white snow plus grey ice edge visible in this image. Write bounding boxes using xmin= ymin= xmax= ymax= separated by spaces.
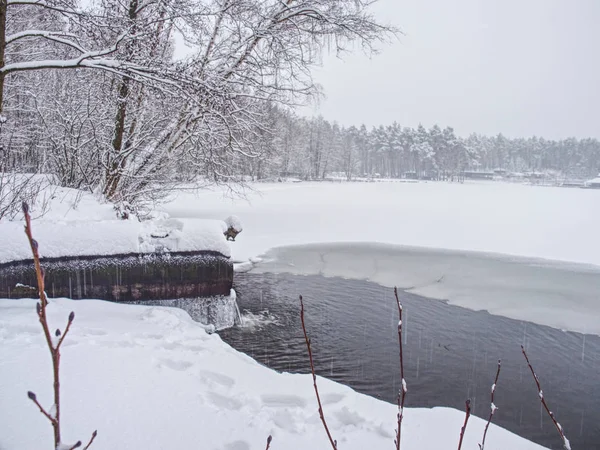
xmin=165 ymin=182 xmax=600 ymax=334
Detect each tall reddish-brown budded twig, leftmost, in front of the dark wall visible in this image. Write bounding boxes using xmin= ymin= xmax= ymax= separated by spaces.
xmin=22 ymin=202 xmax=97 ymax=449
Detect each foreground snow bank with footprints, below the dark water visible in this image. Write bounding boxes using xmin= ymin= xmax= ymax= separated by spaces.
xmin=0 ymin=299 xmax=552 ymax=450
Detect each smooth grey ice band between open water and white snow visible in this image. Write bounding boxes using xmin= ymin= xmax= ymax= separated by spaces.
xmin=253 ymin=243 xmax=600 ymax=335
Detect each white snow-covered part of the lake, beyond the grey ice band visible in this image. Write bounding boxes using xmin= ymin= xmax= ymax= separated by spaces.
xmin=165 ymin=182 xmax=600 ymax=265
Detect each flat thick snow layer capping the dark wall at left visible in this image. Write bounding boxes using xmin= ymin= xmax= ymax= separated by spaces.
xmin=0 ymin=219 xmax=231 ymax=264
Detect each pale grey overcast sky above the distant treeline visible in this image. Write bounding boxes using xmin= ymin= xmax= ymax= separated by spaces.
xmin=303 ymin=0 xmax=600 ymax=139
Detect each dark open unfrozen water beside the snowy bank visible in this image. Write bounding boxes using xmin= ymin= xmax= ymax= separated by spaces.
xmin=220 ymin=274 xmax=600 ymax=450
